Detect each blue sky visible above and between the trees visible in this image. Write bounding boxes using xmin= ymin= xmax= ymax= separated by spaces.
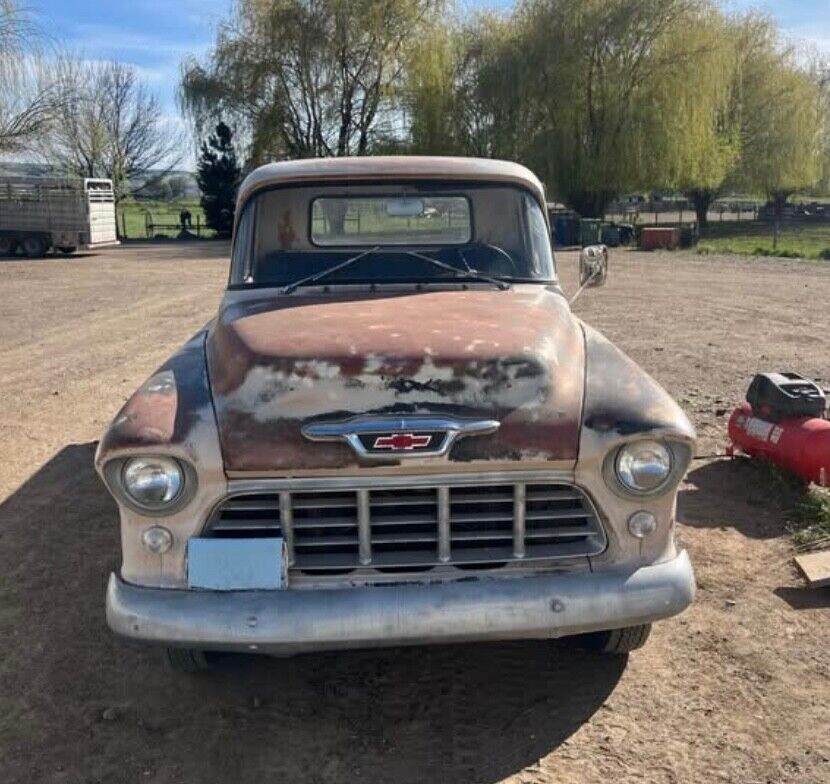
xmin=29 ymin=0 xmax=830 ymax=168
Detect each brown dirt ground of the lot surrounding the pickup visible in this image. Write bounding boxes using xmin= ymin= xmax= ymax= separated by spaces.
xmin=0 ymin=243 xmax=830 ymax=784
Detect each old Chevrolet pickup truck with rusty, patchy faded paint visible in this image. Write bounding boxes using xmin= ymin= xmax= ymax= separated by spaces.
xmin=96 ymin=157 xmax=695 ymax=670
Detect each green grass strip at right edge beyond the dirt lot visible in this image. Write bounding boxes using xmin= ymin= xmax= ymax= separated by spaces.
xmin=698 ymin=222 xmax=830 ymax=259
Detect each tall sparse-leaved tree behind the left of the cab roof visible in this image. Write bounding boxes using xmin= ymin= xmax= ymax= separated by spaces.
xmin=181 ymin=0 xmax=440 ymax=163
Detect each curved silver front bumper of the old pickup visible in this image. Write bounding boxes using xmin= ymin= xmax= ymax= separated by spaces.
xmin=107 ymin=551 xmax=695 ymax=655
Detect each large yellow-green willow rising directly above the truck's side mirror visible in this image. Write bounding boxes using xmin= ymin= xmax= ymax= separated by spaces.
xmin=504 ymin=0 xmax=712 ymax=216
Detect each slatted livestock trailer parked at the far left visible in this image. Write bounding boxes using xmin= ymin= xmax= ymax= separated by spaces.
xmin=0 ymin=177 xmax=118 ymax=258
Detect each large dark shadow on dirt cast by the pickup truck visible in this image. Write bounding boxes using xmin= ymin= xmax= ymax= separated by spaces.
xmin=0 ymin=444 xmax=625 ymax=784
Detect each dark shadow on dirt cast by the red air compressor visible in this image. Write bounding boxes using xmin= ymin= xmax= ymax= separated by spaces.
xmin=678 ymin=458 xmax=786 ymax=539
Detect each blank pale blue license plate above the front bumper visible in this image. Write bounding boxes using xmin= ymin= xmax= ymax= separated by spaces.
xmin=187 ymin=537 xmax=286 ymax=591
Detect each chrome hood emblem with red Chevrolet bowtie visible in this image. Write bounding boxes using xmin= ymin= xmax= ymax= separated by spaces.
xmin=302 ymin=416 xmax=499 ymax=460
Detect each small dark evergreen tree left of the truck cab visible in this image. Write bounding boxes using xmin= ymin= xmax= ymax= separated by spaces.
xmin=196 ymin=121 xmax=242 ymax=237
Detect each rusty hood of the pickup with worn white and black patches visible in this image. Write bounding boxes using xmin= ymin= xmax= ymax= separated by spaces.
xmin=207 ymin=285 xmax=585 ymax=472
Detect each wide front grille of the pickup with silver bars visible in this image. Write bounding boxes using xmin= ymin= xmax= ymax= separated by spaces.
xmin=203 ymin=474 xmax=605 ymax=574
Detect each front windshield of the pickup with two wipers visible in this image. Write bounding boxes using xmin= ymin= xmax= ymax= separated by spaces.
xmin=231 ymin=182 xmax=556 ymax=288
